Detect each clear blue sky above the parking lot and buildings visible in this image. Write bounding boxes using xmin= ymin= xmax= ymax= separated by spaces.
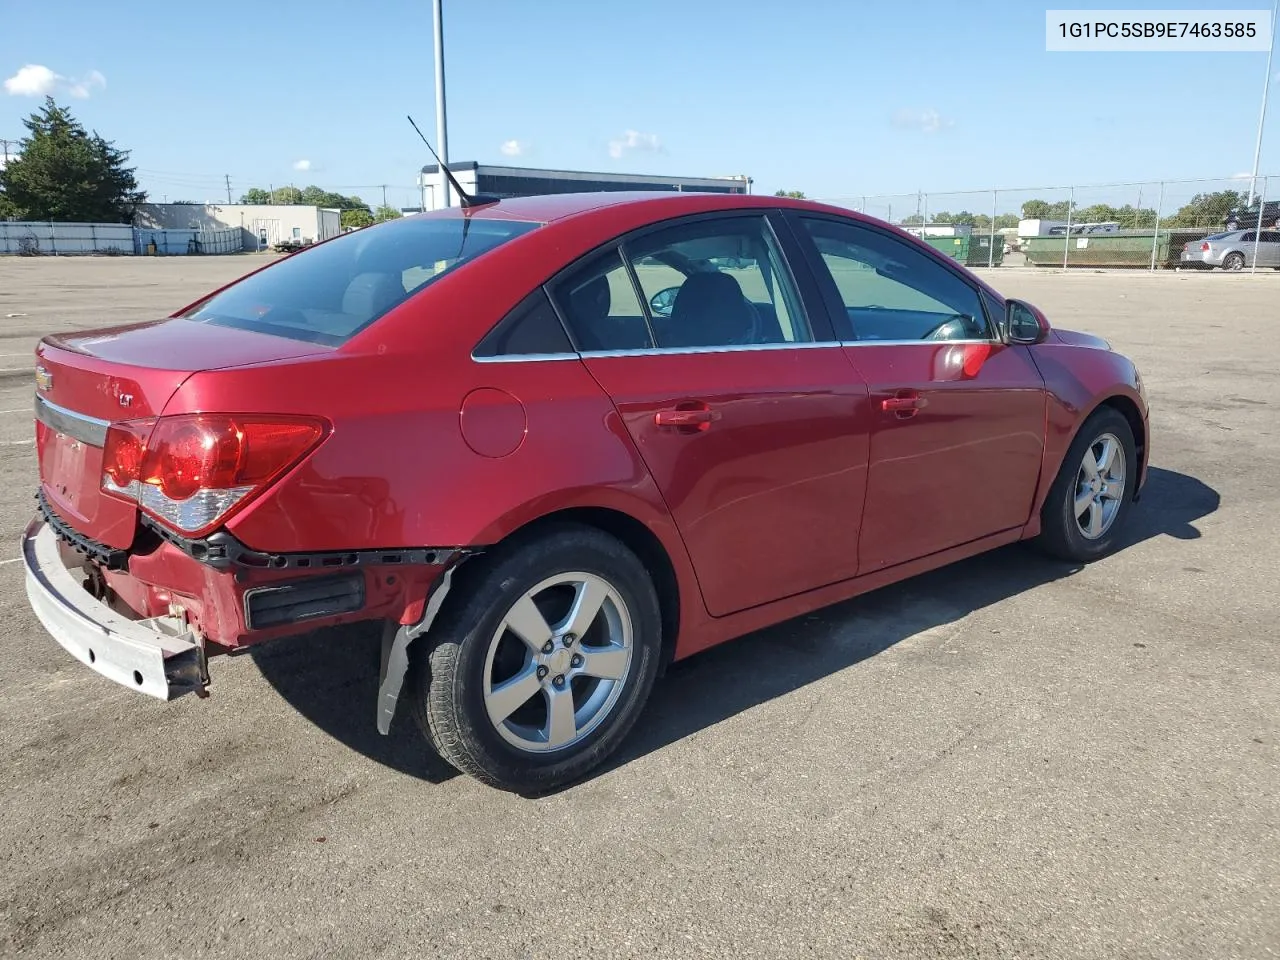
xmin=0 ymin=0 xmax=1280 ymax=205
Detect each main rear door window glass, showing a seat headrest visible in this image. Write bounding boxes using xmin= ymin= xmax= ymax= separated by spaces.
xmin=623 ymin=216 xmax=813 ymax=348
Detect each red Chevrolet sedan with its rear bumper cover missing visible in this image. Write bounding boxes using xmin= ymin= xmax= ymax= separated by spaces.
xmin=23 ymin=193 xmax=1148 ymax=790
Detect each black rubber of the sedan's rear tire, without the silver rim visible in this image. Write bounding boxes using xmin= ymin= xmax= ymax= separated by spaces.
xmin=429 ymin=527 xmax=662 ymax=790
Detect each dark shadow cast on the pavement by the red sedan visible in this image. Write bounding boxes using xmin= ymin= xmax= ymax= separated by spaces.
xmin=252 ymin=467 xmax=1220 ymax=783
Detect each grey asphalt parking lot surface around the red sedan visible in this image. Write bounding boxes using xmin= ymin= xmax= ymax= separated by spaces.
xmin=0 ymin=257 xmax=1280 ymax=960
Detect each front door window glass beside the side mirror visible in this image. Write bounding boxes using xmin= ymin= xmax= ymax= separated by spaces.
xmin=801 ymin=218 xmax=992 ymax=340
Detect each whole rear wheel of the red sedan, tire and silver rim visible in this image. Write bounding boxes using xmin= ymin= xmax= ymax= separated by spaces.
xmin=412 ymin=525 xmax=662 ymax=792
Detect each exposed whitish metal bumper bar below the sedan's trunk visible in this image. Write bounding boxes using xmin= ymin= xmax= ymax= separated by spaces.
xmin=22 ymin=518 xmax=205 ymax=700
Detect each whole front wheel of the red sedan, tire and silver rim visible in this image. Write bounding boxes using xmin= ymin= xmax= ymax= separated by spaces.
xmin=1033 ymin=407 xmax=1140 ymax=563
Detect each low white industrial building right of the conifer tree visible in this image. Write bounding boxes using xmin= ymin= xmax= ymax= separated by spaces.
xmin=134 ymin=204 xmax=342 ymax=250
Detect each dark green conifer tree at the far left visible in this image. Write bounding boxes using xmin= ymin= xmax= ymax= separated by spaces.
xmin=0 ymin=97 xmax=146 ymax=223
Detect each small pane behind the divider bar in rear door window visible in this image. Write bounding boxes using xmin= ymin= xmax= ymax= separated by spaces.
xmin=554 ymin=248 xmax=653 ymax=351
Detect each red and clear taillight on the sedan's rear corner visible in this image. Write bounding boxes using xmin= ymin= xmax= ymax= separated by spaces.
xmin=102 ymin=413 xmax=328 ymax=536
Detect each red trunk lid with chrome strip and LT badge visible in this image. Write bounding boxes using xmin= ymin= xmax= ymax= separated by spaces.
xmin=36 ymin=319 xmax=332 ymax=548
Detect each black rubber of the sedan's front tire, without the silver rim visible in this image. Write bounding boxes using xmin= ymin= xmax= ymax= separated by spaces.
xmin=1046 ymin=407 xmax=1140 ymax=562
